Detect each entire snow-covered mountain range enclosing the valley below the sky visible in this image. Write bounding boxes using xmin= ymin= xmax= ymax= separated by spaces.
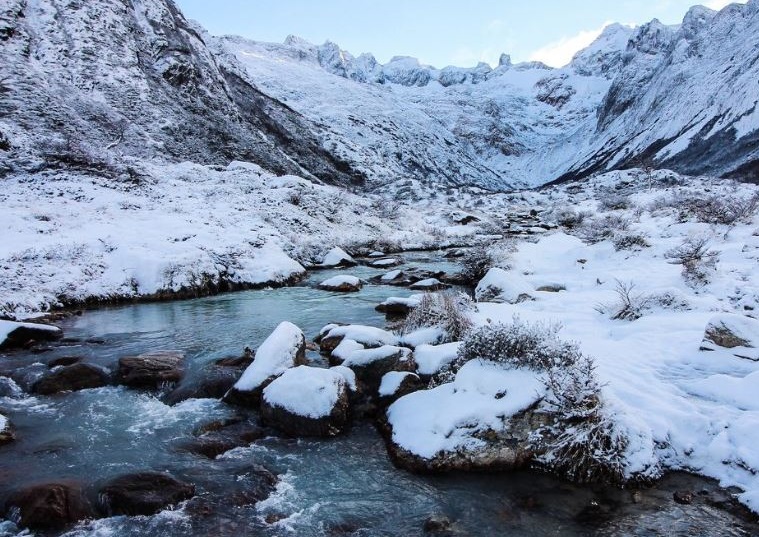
xmin=0 ymin=0 xmax=759 ymax=188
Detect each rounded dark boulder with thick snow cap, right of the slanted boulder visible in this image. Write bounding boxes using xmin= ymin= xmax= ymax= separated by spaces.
xmin=261 ymin=365 xmax=350 ymax=436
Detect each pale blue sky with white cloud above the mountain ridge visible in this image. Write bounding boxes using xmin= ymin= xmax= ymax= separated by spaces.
xmin=175 ymin=0 xmax=745 ymax=67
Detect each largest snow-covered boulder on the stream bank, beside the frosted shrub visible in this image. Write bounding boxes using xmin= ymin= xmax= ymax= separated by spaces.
xmin=387 ymin=361 xmax=545 ymax=471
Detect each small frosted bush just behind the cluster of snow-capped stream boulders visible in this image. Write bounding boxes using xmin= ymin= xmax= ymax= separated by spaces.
xmin=400 ymin=291 xmax=475 ymax=341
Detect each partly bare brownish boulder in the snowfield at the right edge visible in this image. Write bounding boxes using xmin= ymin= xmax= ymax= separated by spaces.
xmin=701 ymin=313 xmax=759 ymax=361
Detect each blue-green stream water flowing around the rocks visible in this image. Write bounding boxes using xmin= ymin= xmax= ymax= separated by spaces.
xmin=0 ymin=254 xmax=757 ymax=536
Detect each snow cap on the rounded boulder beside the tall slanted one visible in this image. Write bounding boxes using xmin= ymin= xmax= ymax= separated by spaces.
xmin=263 ymin=365 xmax=346 ymax=419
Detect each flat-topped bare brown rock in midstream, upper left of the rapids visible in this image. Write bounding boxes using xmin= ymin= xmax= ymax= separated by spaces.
xmin=117 ymin=351 xmax=184 ymax=389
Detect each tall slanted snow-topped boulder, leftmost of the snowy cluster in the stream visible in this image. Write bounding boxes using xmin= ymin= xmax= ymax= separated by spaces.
xmin=224 ymin=321 xmax=306 ymax=406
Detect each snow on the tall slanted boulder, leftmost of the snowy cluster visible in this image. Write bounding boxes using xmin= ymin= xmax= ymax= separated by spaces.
xmin=234 ymin=321 xmax=305 ymax=391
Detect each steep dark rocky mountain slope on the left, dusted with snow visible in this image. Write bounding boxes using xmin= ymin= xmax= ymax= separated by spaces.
xmin=0 ymin=0 xmax=363 ymax=184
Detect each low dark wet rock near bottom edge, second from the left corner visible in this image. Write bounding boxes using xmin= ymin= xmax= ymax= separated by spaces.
xmin=98 ymin=472 xmax=195 ymax=516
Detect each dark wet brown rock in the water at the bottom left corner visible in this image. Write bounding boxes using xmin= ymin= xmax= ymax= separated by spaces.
xmin=5 ymin=483 xmax=95 ymax=530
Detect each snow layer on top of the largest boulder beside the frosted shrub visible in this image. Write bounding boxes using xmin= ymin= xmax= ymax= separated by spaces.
xmin=387 ymin=360 xmax=545 ymax=459
